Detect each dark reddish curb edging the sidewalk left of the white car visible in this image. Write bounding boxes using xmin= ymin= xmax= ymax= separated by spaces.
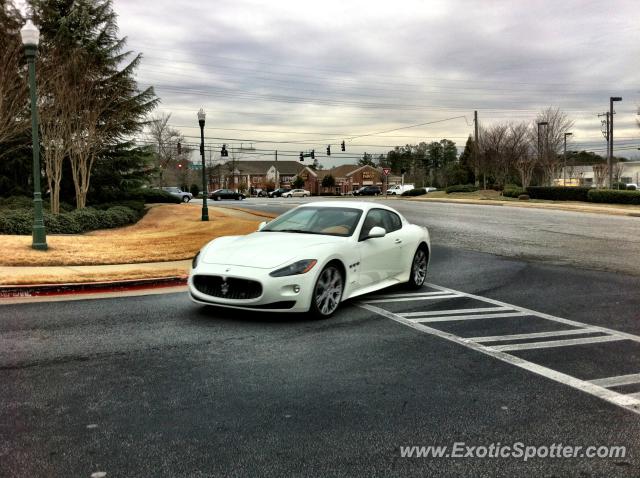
xmin=0 ymin=276 xmax=187 ymax=299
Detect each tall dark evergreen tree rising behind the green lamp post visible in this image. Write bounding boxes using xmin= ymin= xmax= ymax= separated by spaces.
xmin=28 ymin=0 xmax=158 ymax=209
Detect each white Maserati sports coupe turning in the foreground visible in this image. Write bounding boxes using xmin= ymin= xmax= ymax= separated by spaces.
xmin=189 ymin=201 xmax=431 ymax=318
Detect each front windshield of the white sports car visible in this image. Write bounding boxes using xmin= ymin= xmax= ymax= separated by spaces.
xmin=261 ymin=206 xmax=362 ymax=237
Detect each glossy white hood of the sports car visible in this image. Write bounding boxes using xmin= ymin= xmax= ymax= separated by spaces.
xmin=202 ymin=232 xmax=347 ymax=269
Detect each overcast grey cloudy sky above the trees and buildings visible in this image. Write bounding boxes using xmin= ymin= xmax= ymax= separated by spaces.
xmin=107 ymin=0 xmax=640 ymax=167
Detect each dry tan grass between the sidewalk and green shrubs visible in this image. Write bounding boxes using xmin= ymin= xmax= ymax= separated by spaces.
xmin=0 ymin=204 xmax=260 ymax=266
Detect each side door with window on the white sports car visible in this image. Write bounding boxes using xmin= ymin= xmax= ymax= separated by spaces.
xmin=357 ymin=209 xmax=402 ymax=287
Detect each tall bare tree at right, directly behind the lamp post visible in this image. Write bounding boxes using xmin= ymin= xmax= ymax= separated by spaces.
xmin=535 ymin=107 xmax=574 ymax=184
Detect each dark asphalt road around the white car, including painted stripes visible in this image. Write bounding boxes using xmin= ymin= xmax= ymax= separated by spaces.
xmin=0 ymin=200 xmax=640 ymax=477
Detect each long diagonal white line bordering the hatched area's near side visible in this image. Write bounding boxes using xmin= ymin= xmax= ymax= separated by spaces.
xmin=359 ymin=299 xmax=640 ymax=414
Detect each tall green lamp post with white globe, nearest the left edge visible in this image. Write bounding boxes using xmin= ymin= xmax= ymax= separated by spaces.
xmin=20 ymin=20 xmax=47 ymax=251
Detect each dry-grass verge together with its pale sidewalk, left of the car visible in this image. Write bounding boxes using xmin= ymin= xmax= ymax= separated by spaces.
xmin=0 ymin=204 xmax=276 ymax=286
